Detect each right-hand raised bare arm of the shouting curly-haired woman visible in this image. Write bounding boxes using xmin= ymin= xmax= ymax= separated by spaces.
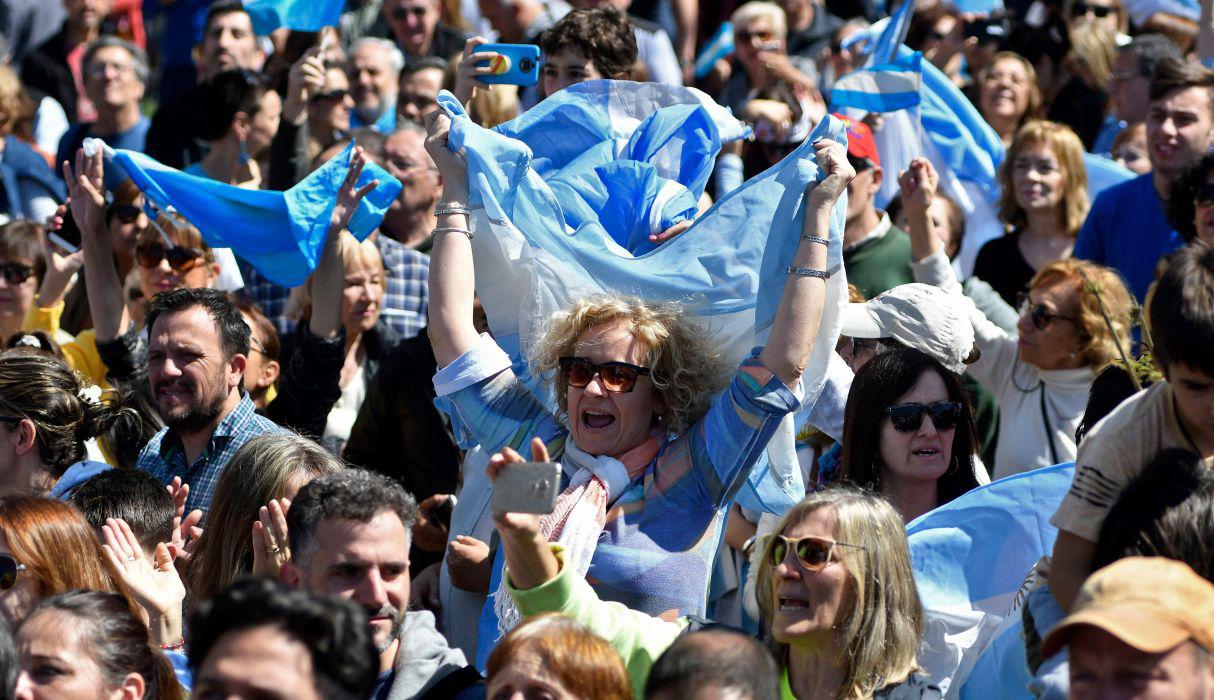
xmin=759 ymin=140 xmax=856 ymax=386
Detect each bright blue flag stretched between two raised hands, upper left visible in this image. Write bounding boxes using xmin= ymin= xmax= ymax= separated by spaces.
xmin=113 ymin=143 xmax=401 ymax=286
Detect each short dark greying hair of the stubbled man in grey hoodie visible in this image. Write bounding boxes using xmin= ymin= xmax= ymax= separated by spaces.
xmin=287 ymin=469 xmax=418 ymax=568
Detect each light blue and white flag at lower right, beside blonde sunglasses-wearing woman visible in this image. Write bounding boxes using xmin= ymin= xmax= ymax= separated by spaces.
xmin=907 ymin=462 xmax=1074 ymax=698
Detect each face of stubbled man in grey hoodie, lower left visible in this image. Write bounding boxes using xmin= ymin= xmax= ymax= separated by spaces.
xmin=296 ymin=511 xmax=409 ymax=653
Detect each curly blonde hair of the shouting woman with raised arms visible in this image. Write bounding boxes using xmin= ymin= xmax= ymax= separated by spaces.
xmin=532 ymin=296 xmax=726 ymax=434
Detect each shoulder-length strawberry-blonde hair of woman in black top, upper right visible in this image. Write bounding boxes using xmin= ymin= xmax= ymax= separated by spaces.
xmin=999 ymin=119 xmax=1090 ymax=237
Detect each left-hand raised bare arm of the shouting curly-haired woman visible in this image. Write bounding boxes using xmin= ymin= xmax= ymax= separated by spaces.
xmin=426 ymin=112 xmax=480 ymax=368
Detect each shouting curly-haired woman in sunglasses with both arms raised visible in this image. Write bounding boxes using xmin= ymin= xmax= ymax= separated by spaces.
xmin=426 ymin=113 xmax=855 ymax=653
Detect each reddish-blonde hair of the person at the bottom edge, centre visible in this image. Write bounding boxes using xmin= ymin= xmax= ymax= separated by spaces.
xmin=488 ymin=613 xmax=632 ymax=700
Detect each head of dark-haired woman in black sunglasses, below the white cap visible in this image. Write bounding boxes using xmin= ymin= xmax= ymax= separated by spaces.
xmin=839 ymin=347 xmax=978 ymax=523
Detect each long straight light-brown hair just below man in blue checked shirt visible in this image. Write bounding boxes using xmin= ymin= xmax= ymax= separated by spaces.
xmin=188 ymin=433 xmax=345 ymax=604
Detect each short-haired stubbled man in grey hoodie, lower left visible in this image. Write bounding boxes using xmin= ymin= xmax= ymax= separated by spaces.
xmin=279 ymin=469 xmax=484 ymax=700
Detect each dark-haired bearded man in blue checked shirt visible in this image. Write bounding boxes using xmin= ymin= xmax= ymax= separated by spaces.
xmin=136 ymin=289 xmax=282 ymax=512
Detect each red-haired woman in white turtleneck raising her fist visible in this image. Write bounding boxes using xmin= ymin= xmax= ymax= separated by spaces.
xmin=900 ymin=158 xmax=1133 ymax=478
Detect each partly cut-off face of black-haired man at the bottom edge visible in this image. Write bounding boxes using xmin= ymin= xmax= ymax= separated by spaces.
xmin=193 ymin=626 xmax=320 ymax=700
